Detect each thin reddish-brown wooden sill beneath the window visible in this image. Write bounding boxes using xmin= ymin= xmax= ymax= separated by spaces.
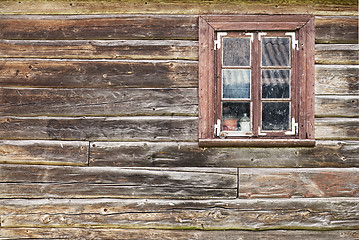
xmin=198 ymin=139 xmax=315 ymax=147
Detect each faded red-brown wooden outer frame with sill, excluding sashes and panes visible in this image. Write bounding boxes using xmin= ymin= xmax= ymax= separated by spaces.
xmin=198 ymin=15 xmax=315 ymax=147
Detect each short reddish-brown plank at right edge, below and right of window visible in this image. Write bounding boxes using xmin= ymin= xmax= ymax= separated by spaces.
xmin=239 ymin=168 xmax=359 ymax=198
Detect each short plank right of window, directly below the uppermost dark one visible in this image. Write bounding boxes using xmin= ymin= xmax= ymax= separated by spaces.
xmin=315 ymin=44 xmax=359 ymax=65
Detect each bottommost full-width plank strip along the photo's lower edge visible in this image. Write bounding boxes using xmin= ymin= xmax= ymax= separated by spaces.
xmin=0 ymin=227 xmax=359 ymax=240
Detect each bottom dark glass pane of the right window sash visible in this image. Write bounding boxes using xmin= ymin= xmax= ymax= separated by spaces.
xmin=262 ymin=102 xmax=290 ymax=131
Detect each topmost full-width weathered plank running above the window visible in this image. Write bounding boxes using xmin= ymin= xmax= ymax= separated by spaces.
xmin=0 ymin=0 xmax=358 ymax=16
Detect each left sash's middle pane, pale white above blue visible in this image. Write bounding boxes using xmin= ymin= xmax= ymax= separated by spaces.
xmin=222 ymin=69 xmax=251 ymax=99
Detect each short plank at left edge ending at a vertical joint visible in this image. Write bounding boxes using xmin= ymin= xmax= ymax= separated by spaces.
xmin=0 ymin=140 xmax=89 ymax=166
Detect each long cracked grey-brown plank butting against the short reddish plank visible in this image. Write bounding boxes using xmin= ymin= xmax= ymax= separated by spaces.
xmin=0 ymin=165 xmax=237 ymax=199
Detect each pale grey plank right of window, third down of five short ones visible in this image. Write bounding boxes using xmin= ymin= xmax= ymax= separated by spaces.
xmin=315 ymin=65 xmax=359 ymax=94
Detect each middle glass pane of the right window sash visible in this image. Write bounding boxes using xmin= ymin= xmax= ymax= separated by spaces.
xmin=262 ymin=70 xmax=290 ymax=98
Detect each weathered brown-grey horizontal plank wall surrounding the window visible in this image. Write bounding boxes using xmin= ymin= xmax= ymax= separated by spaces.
xmin=0 ymin=0 xmax=359 ymax=240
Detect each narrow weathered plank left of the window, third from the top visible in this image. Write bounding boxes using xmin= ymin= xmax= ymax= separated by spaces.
xmin=0 ymin=39 xmax=198 ymax=60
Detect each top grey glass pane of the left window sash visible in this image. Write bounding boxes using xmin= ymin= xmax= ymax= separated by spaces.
xmin=223 ymin=38 xmax=251 ymax=66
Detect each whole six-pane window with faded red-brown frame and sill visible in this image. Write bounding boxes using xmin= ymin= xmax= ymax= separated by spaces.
xmin=199 ymin=15 xmax=315 ymax=146
